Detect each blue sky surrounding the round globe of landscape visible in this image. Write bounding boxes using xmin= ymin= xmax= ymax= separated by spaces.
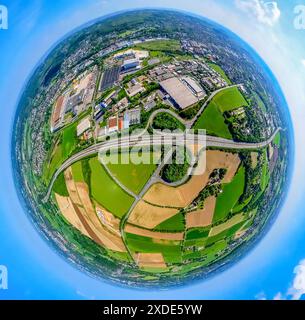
xmin=0 ymin=0 xmax=305 ymax=299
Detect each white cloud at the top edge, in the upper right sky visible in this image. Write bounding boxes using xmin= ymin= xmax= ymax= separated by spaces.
xmin=235 ymin=0 xmax=281 ymax=27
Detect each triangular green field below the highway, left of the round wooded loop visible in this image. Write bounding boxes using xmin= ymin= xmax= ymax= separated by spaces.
xmin=107 ymin=153 xmax=157 ymax=194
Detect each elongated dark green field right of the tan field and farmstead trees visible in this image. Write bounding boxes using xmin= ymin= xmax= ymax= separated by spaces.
xmin=213 ymin=167 xmax=245 ymax=223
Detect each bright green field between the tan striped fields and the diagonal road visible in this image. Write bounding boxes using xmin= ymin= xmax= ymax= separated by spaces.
xmin=89 ymin=158 xmax=134 ymax=218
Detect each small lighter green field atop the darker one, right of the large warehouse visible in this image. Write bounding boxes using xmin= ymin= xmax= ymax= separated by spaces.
xmin=213 ymin=87 xmax=248 ymax=112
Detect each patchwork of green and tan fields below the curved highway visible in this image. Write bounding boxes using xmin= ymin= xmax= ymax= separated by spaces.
xmin=53 ymin=142 xmax=268 ymax=273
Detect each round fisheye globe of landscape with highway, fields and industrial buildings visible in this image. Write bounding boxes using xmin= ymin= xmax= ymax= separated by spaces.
xmin=13 ymin=10 xmax=291 ymax=288
